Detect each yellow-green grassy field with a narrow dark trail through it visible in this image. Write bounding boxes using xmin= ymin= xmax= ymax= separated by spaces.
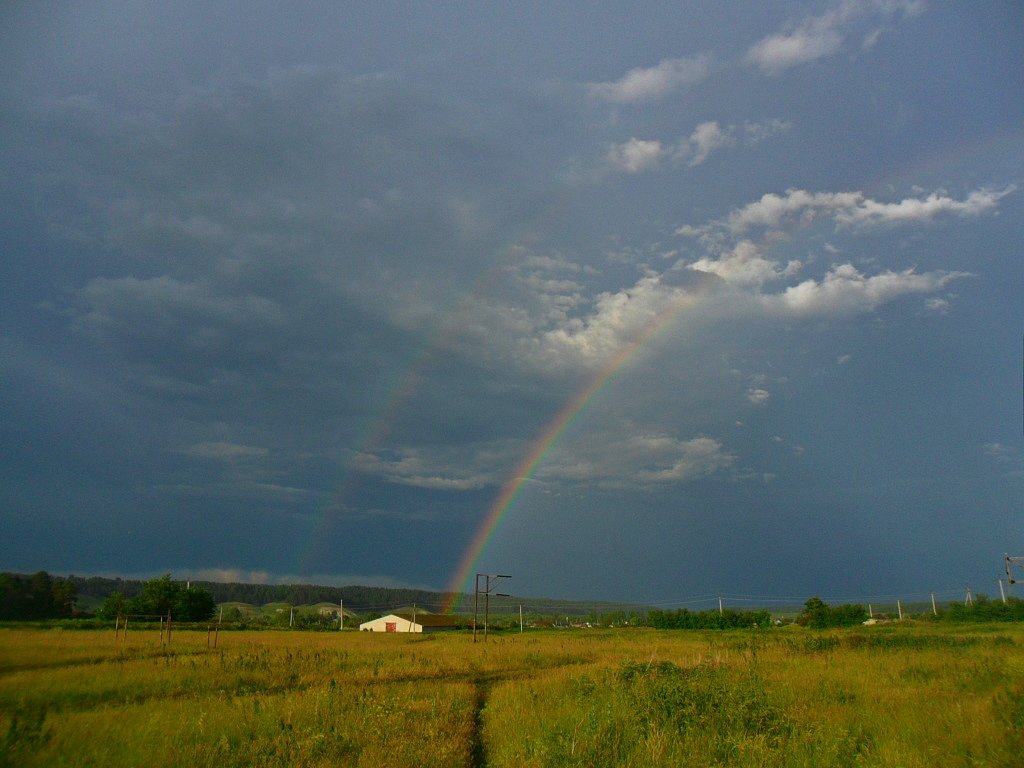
xmin=0 ymin=624 xmax=1024 ymax=768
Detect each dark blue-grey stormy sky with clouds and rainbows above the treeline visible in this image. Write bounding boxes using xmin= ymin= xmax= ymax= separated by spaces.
xmin=0 ymin=0 xmax=1024 ymax=606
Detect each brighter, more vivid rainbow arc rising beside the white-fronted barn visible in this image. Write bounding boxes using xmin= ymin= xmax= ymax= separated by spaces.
xmin=443 ymin=295 xmax=692 ymax=613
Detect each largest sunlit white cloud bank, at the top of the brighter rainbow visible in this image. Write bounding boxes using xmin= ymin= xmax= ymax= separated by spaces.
xmin=466 ymin=187 xmax=1013 ymax=380
